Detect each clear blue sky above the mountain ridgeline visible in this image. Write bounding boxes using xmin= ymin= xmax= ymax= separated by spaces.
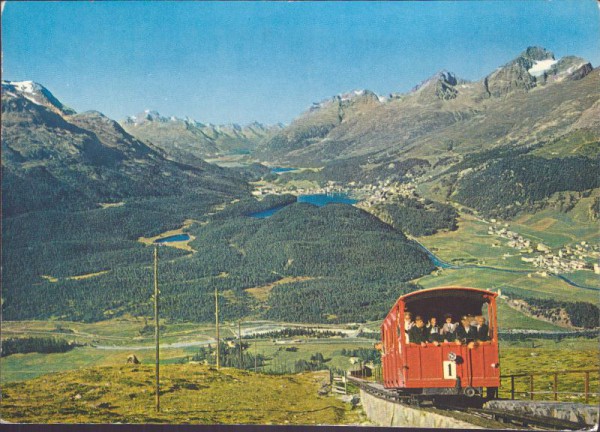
xmin=2 ymin=0 xmax=600 ymax=124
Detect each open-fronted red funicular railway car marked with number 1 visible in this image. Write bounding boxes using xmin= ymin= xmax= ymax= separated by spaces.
xmin=381 ymin=287 xmax=500 ymax=403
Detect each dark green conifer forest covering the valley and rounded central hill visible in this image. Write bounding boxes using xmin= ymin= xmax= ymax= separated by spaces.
xmin=3 ymin=194 xmax=434 ymax=322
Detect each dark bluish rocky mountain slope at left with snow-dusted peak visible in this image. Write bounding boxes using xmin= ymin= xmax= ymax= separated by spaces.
xmin=2 ymin=82 xmax=247 ymax=216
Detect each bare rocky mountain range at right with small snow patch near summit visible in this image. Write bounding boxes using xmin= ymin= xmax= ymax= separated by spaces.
xmin=259 ymin=47 xmax=600 ymax=170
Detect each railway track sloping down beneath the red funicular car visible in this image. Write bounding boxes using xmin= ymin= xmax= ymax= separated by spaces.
xmin=348 ymin=377 xmax=589 ymax=430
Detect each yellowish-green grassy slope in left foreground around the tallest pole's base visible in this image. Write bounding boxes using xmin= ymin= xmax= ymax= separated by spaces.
xmin=2 ymin=365 xmax=360 ymax=424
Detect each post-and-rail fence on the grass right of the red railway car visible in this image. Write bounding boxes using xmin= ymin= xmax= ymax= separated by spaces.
xmin=499 ymin=369 xmax=600 ymax=404
